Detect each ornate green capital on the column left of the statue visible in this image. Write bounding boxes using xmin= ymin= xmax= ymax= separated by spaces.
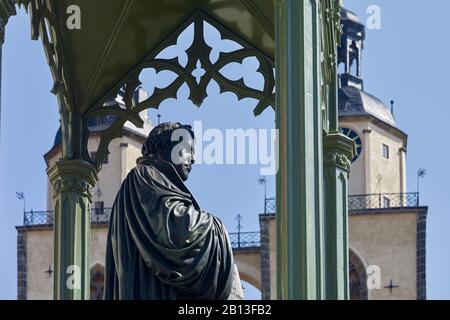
xmin=47 ymin=160 xmax=97 ymax=199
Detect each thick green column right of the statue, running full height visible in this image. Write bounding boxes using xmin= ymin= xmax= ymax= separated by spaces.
xmin=275 ymin=0 xmax=325 ymax=299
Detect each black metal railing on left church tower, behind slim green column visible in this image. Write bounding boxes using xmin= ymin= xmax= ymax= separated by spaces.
xmin=23 ymin=208 xmax=111 ymax=226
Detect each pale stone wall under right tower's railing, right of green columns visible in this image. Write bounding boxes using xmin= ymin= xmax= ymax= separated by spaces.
xmin=349 ymin=207 xmax=427 ymax=300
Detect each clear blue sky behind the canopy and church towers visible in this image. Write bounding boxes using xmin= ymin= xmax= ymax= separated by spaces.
xmin=0 ymin=0 xmax=450 ymax=299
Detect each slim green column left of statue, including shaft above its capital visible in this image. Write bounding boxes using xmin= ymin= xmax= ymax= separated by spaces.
xmin=47 ymin=108 xmax=97 ymax=300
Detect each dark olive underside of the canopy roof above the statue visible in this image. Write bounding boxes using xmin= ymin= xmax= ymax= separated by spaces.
xmin=32 ymin=0 xmax=274 ymax=111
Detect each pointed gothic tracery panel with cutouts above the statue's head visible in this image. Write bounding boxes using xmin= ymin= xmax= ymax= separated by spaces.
xmin=86 ymin=12 xmax=275 ymax=166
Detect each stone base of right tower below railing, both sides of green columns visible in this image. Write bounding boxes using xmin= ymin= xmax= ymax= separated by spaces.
xmin=260 ymin=207 xmax=428 ymax=300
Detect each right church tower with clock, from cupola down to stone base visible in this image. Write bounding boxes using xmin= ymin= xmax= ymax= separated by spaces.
xmin=338 ymin=9 xmax=428 ymax=300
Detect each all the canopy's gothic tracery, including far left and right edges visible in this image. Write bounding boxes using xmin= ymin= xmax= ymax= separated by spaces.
xmin=16 ymin=0 xmax=341 ymax=170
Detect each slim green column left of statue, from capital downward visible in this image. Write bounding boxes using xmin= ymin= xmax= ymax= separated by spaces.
xmin=47 ymin=158 xmax=97 ymax=300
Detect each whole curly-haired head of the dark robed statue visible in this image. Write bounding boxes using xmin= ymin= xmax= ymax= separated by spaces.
xmin=142 ymin=122 xmax=195 ymax=181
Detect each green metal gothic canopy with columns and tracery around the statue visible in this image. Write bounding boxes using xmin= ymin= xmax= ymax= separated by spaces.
xmin=0 ymin=0 xmax=354 ymax=299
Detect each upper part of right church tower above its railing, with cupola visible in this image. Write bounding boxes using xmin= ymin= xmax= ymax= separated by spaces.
xmin=338 ymin=10 xmax=407 ymax=198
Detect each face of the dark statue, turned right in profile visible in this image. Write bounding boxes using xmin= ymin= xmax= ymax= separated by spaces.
xmin=165 ymin=134 xmax=195 ymax=181
